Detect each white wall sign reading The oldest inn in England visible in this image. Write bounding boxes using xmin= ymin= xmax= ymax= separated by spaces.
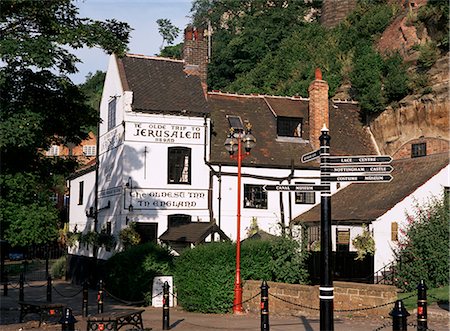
xmin=124 ymin=189 xmax=208 ymax=210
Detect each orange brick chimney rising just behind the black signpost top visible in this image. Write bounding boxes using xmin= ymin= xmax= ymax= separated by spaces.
xmin=308 ymin=68 xmax=330 ymax=149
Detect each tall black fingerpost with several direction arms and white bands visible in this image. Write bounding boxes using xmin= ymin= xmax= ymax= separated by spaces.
xmin=300 ymin=126 xmax=393 ymax=331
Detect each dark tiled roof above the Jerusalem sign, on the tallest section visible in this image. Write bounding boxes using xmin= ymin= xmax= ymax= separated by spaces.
xmin=117 ymin=54 xmax=209 ymax=116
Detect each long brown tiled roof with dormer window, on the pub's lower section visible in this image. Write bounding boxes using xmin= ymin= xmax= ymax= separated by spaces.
xmin=208 ymin=92 xmax=377 ymax=168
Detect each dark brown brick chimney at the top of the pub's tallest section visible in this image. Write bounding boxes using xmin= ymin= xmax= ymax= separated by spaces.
xmin=183 ymin=26 xmax=208 ymax=91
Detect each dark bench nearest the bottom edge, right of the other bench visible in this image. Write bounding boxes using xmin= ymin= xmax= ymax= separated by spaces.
xmin=87 ymin=309 xmax=144 ymax=331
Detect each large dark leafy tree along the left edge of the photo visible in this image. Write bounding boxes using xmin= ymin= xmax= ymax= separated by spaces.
xmin=0 ymin=0 xmax=131 ymax=245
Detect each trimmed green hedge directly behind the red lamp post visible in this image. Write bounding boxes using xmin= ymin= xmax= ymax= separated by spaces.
xmin=175 ymin=237 xmax=308 ymax=313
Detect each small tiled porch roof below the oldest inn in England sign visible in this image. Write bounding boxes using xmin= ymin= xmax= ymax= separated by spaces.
xmin=159 ymin=222 xmax=230 ymax=244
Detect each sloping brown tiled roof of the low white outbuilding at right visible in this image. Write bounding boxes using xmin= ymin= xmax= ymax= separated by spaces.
xmin=293 ymin=153 xmax=449 ymax=223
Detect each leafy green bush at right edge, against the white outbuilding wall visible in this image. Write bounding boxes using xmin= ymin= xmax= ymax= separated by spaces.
xmin=396 ymin=196 xmax=450 ymax=291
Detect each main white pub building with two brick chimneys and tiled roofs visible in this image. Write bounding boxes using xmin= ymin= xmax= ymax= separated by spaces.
xmin=69 ymin=28 xmax=446 ymax=279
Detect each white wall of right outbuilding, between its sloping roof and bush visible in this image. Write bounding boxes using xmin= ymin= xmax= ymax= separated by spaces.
xmin=371 ymin=166 xmax=450 ymax=271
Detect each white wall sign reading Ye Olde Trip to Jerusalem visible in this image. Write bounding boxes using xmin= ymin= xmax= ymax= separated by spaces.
xmin=125 ymin=122 xmax=204 ymax=145
